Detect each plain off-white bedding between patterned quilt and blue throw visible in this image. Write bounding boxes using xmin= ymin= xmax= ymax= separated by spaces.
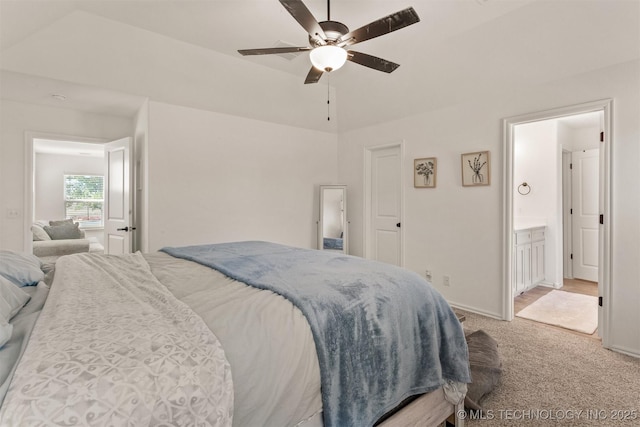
xmin=144 ymin=252 xmax=322 ymax=427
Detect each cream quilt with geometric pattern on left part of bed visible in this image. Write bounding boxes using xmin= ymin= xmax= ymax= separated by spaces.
xmin=0 ymin=254 xmax=233 ymax=426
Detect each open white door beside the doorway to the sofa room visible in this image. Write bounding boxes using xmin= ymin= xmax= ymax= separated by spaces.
xmin=104 ymin=138 xmax=135 ymax=255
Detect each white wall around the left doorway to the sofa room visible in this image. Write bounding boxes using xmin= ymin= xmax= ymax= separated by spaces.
xmin=0 ymin=99 xmax=133 ymax=251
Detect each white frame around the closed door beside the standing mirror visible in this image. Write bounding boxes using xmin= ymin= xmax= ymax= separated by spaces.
xmin=362 ymin=140 xmax=405 ymax=267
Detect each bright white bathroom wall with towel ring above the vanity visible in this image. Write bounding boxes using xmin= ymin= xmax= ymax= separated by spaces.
xmin=513 ymin=120 xmax=562 ymax=287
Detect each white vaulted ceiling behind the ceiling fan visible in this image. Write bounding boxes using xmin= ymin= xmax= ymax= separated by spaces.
xmin=0 ymin=0 xmax=640 ymax=132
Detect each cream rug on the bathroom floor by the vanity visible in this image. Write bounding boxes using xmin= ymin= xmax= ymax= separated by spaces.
xmin=516 ymin=289 xmax=598 ymax=334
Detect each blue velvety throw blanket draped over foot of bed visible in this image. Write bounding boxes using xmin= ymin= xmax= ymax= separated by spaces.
xmin=162 ymin=242 xmax=471 ymax=426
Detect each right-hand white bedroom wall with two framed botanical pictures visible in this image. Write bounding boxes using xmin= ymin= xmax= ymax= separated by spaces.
xmin=338 ymin=61 xmax=640 ymax=355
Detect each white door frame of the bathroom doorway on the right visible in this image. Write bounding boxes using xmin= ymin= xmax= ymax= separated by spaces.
xmin=502 ymin=99 xmax=613 ymax=348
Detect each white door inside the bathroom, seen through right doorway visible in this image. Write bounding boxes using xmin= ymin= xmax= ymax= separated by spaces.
xmin=571 ymin=148 xmax=600 ymax=282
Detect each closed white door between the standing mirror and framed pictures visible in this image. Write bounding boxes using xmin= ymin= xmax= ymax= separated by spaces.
xmin=367 ymin=146 xmax=402 ymax=266
